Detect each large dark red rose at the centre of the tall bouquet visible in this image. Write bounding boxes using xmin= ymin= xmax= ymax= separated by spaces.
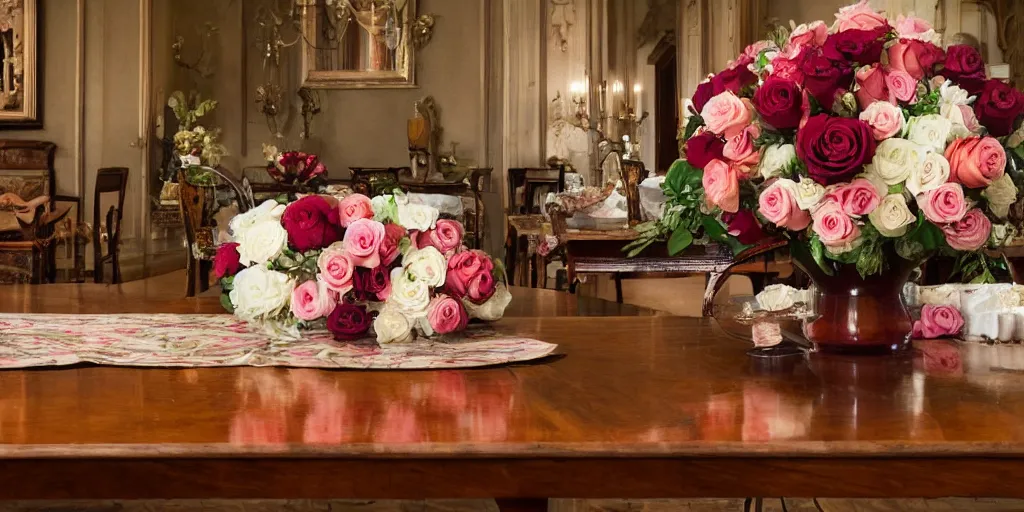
xmin=797 ymin=114 xmax=876 ymax=185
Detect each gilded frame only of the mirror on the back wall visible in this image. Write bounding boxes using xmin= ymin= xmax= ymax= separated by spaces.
xmin=301 ymin=0 xmax=417 ymax=89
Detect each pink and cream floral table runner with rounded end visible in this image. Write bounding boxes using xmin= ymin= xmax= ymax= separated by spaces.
xmin=0 ymin=313 xmax=557 ymax=370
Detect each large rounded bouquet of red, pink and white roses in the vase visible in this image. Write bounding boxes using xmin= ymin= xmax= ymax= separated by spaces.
xmin=628 ymin=1 xmax=1024 ymax=283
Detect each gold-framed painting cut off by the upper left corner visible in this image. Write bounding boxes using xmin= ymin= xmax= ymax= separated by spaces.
xmin=0 ymin=0 xmax=37 ymax=129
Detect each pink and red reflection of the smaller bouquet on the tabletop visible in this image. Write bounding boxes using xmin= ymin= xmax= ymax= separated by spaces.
xmin=229 ymin=370 xmax=516 ymax=444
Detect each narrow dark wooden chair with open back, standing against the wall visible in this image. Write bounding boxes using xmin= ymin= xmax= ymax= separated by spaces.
xmin=92 ymin=167 xmax=128 ymax=285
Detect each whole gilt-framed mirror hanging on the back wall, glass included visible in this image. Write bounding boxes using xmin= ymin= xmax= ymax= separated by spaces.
xmin=299 ymin=0 xmax=418 ymax=89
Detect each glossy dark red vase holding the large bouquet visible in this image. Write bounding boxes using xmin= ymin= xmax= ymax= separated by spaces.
xmin=791 ymin=243 xmax=922 ymax=354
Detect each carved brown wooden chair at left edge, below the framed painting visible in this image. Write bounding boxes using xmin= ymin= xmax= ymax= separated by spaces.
xmin=0 ymin=140 xmax=81 ymax=284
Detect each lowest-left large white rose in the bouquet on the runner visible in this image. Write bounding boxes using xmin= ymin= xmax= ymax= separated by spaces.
xmin=227 ymin=266 xmax=295 ymax=322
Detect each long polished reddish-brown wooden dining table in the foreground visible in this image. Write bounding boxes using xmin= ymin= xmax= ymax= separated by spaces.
xmin=0 ymin=285 xmax=1024 ymax=510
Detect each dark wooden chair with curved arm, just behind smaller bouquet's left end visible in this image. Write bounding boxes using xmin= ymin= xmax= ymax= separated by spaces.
xmin=178 ymin=167 xmax=254 ymax=297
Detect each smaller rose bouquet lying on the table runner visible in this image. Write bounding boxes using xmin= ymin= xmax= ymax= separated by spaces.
xmin=214 ymin=191 xmax=511 ymax=343
